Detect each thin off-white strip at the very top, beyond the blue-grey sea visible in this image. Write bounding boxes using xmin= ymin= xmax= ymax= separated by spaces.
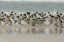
xmin=0 ymin=0 xmax=64 ymax=2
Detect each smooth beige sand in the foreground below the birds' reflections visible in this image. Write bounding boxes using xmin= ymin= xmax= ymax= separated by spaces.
xmin=0 ymin=35 xmax=64 ymax=42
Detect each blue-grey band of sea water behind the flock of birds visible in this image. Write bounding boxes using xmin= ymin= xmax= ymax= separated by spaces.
xmin=0 ymin=1 xmax=64 ymax=12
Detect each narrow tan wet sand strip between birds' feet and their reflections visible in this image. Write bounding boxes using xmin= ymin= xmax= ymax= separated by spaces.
xmin=0 ymin=25 xmax=52 ymax=28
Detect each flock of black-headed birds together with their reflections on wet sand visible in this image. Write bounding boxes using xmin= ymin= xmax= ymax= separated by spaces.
xmin=0 ymin=11 xmax=64 ymax=34
